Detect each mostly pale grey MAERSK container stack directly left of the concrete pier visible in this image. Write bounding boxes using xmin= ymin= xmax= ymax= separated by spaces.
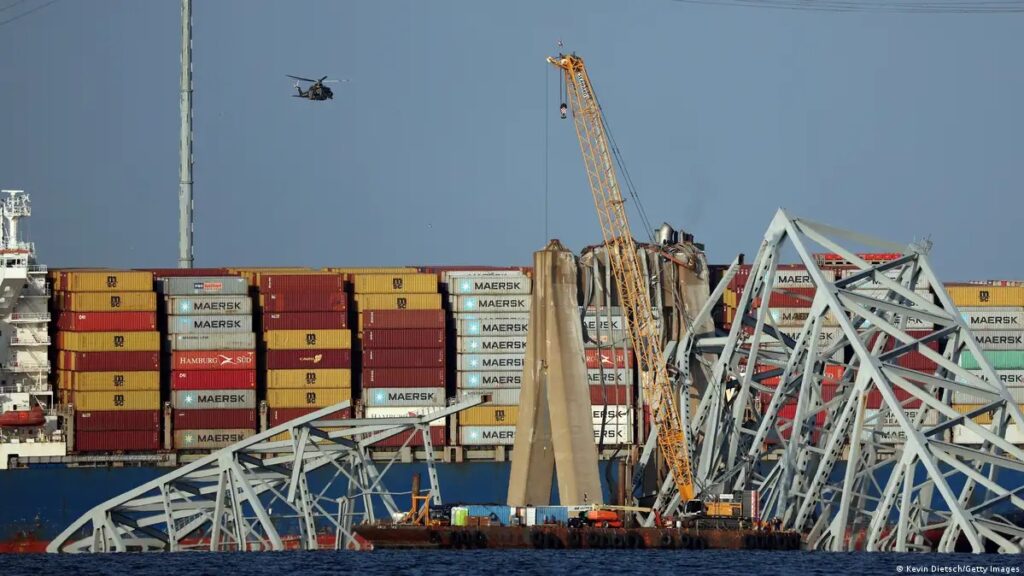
xmin=443 ymin=270 xmax=531 ymax=446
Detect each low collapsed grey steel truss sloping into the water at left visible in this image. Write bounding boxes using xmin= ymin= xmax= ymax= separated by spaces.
xmin=47 ymin=396 xmax=485 ymax=552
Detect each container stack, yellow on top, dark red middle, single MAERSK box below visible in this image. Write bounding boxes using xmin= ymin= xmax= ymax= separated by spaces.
xmin=353 ymin=273 xmax=447 ymax=448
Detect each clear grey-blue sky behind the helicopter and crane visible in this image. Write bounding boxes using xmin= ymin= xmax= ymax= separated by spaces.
xmin=0 ymin=0 xmax=1024 ymax=280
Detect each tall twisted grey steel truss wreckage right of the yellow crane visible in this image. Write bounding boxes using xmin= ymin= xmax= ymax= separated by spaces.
xmin=675 ymin=210 xmax=1024 ymax=552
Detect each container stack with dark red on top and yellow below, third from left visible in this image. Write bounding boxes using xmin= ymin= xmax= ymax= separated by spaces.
xmin=255 ymin=273 xmax=352 ymax=427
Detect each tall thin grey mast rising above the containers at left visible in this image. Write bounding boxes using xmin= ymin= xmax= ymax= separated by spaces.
xmin=178 ymin=0 xmax=193 ymax=269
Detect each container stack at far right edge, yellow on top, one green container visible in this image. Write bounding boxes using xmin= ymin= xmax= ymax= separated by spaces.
xmin=946 ymin=282 xmax=1024 ymax=444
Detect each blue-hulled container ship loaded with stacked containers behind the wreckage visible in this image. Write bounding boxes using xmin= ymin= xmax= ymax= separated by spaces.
xmin=0 ymin=193 xmax=1024 ymax=551
